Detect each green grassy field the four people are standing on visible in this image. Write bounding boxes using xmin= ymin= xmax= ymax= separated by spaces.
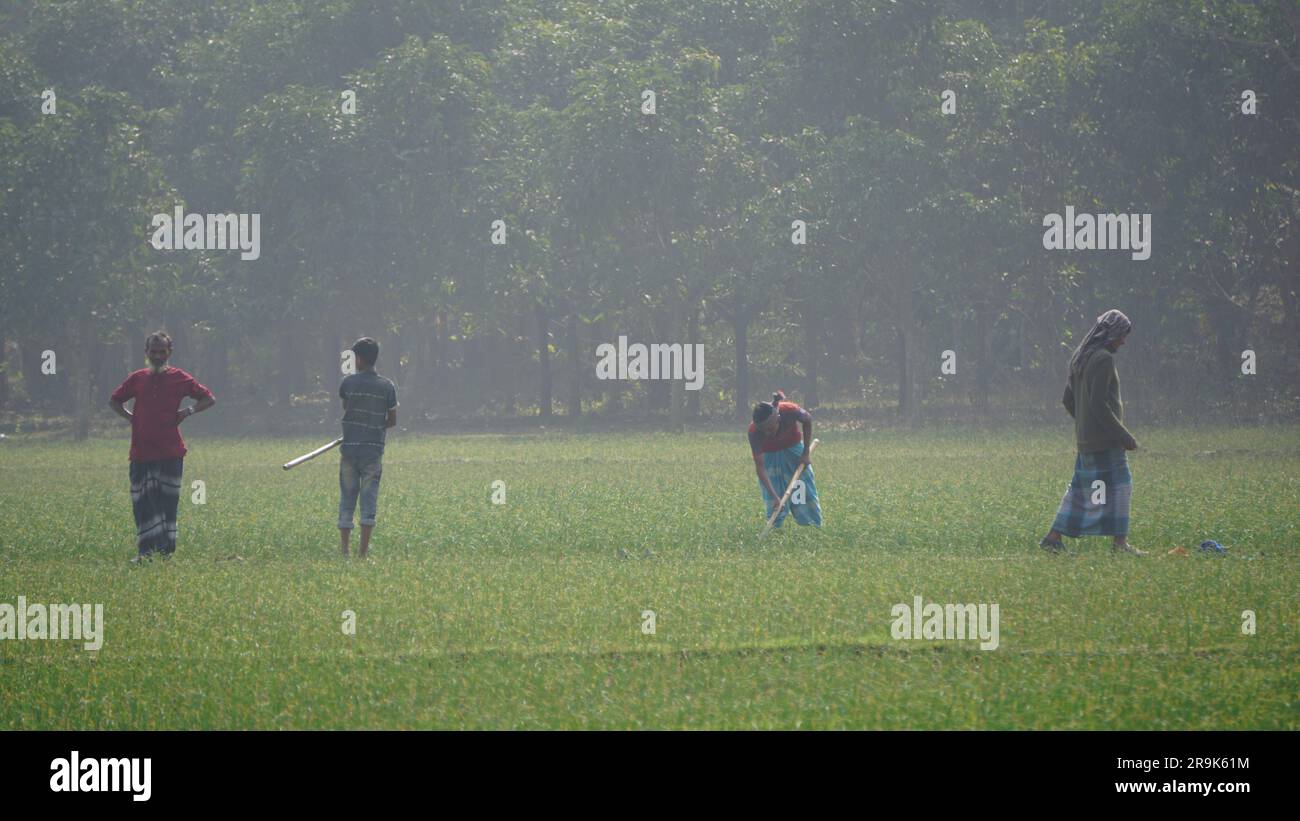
xmin=0 ymin=423 xmax=1300 ymax=729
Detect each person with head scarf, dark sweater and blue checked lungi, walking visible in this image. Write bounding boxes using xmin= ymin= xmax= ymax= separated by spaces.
xmin=1039 ymin=308 xmax=1147 ymax=555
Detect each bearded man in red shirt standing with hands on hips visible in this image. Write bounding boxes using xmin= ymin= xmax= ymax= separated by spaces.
xmin=108 ymin=331 xmax=217 ymax=561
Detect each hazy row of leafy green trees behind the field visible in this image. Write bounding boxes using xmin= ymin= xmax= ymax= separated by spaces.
xmin=0 ymin=0 xmax=1300 ymax=434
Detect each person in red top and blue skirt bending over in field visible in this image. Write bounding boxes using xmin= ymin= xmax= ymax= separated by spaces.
xmin=749 ymin=391 xmax=822 ymax=527
